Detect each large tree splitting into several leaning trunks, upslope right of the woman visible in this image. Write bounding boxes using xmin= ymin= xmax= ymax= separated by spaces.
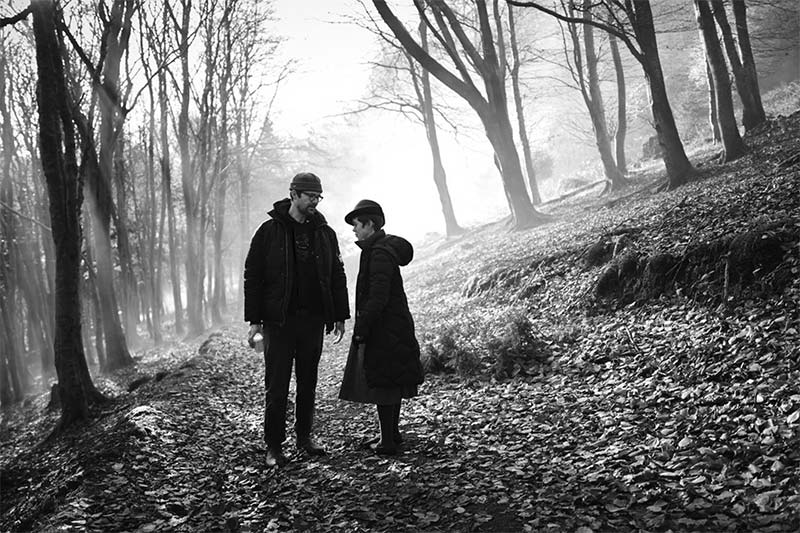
xmin=373 ymin=0 xmax=547 ymax=228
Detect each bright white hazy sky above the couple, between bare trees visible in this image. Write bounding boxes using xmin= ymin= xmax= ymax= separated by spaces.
xmin=266 ymin=0 xmax=508 ymax=240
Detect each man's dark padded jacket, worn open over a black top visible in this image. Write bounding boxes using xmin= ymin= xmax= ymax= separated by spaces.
xmin=244 ymin=198 xmax=350 ymax=332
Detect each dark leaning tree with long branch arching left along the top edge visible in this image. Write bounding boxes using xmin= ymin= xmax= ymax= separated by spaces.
xmin=506 ymin=0 xmax=694 ymax=189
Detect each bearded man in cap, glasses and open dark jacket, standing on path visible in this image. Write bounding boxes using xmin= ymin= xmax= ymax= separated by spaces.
xmin=244 ymin=172 xmax=350 ymax=467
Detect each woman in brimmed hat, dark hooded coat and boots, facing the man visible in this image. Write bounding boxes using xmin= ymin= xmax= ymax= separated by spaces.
xmin=339 ymin=200 xmax=423 ymax=455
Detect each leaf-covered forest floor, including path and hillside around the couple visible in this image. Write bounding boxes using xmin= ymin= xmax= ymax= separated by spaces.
xmin=0 ymin=109 xmax=800 ymax=533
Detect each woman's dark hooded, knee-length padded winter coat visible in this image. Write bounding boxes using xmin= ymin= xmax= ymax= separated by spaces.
xmin=353 ymin=230 xmax=423 ymax=388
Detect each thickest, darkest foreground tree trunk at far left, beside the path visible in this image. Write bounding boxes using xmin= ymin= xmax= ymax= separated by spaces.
xmin=31 ymin=0 xmax=102 ymax=428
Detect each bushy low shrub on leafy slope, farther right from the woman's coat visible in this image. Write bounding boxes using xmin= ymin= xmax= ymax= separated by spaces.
xmin=486 ymin=313 xmax=552 ymax=379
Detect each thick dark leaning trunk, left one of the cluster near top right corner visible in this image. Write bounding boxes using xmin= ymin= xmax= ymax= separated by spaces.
xmin=694 ymin=0 xmax=746 ymax=161
